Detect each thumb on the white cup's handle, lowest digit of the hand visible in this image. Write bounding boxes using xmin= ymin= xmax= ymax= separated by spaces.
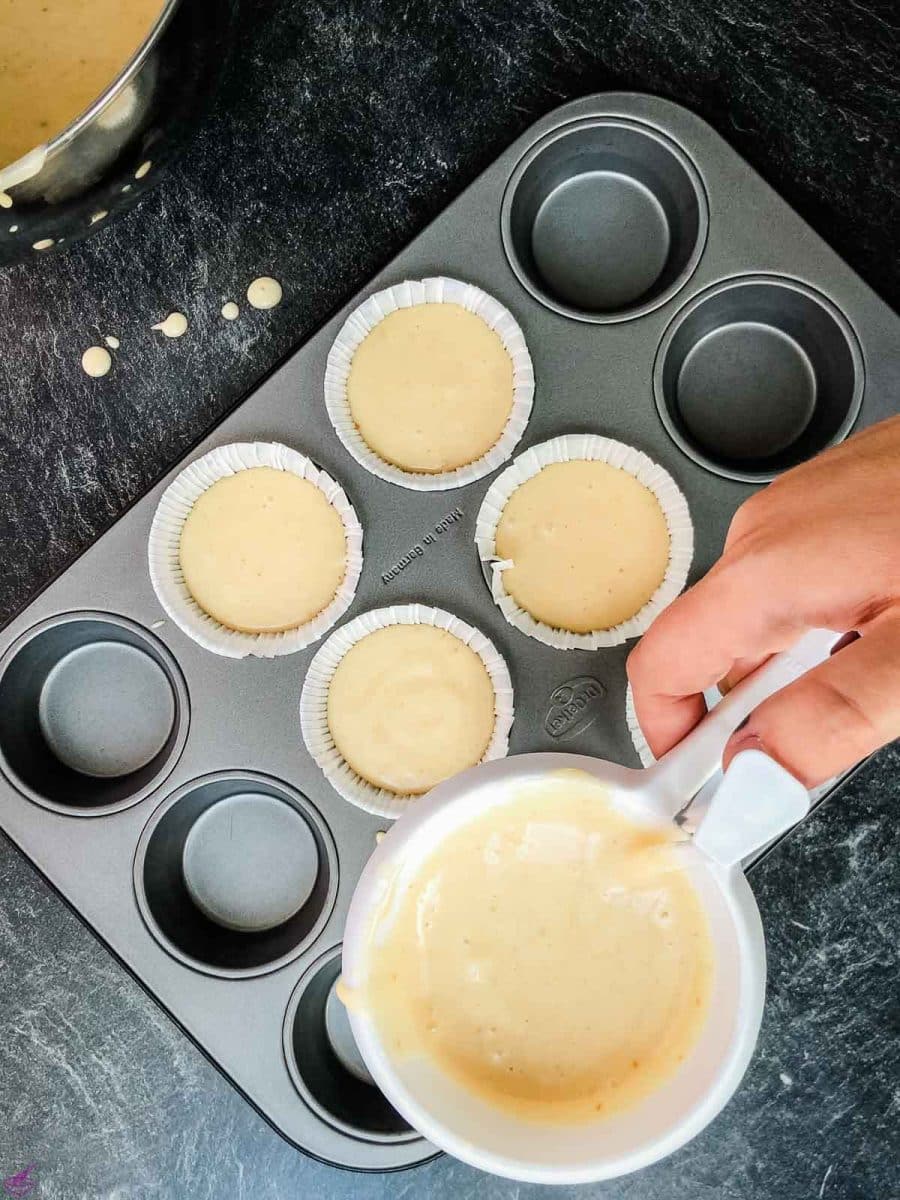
xmin=724 ymin=614 xmax=900 ymax=787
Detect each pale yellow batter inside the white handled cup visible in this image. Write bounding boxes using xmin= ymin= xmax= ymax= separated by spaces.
xmin=362 ymin=772 xmax=713 ymax=1123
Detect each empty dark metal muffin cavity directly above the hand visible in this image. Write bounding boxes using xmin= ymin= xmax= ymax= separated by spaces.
xmin=654 ymin=275 xmax=863 ymax=482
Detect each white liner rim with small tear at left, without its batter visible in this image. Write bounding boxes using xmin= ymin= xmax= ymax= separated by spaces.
xmin=475 ymin=433 xmax=694 ymax=650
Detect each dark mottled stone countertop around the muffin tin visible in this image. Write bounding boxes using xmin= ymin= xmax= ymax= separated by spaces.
xmin=0 ymin=0 xmax=900 ymax=1200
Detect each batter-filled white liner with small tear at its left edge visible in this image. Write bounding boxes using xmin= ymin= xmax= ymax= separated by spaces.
xmin=475 ymin=434 xmax=694 ymax=649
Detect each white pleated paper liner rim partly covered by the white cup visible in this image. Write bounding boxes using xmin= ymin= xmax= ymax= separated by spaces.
xmin=300 ymin=604 xmax=514 ymax=820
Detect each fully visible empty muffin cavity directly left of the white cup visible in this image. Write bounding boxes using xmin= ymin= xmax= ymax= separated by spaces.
xmin=134 ymin=772 xmax=337 ymax=978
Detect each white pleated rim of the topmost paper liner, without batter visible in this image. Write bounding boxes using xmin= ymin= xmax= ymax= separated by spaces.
xmin=325 ymin=276 xmax=534 ymax=492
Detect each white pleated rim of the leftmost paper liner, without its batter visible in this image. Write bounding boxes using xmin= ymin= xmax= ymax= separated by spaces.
xmin=148 ymin=442 xmax=362 ymax=659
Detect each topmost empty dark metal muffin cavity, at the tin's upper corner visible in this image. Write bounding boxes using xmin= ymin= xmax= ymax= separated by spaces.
xmin=502 ymin=116 xmax=708 ymax=323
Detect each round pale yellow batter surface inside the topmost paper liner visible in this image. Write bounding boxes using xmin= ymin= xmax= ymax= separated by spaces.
xmin=347 ymin=304 xmax=512 ymax=474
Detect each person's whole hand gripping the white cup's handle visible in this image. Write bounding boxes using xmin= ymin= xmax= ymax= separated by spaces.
xmin=628 ymin=418 xmax=900 ymax=787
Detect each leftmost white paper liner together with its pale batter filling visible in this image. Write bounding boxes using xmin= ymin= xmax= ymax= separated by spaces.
xmin=148 ymin=442 xmax=362 ymax=658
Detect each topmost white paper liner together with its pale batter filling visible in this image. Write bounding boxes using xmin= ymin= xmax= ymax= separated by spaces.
xmin=325 ymin=277 xmax=534 ymax=491
